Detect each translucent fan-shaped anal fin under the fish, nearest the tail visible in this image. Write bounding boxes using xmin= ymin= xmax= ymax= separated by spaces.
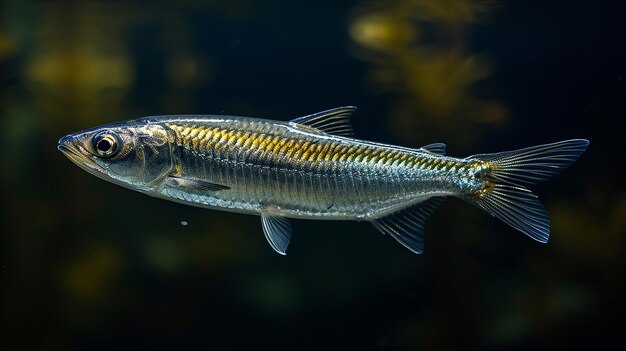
xmin=372 ymin=197 xmax=444 ymax=254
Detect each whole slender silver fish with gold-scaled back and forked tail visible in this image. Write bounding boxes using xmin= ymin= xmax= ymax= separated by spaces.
xmin=58 ymin=106 xmax=589 ymax=255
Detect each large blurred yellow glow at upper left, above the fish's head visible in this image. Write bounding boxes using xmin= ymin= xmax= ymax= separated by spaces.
xmin=20 ymin=2 xmax=135 ymax=120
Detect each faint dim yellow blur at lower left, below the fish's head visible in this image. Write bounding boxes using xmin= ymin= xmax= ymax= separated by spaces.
xmin=63 ymin=246 xmax=122 ymax=302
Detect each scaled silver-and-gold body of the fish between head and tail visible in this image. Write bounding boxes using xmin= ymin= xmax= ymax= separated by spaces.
xmin=162 ymin=117 xmax=472 ymax=220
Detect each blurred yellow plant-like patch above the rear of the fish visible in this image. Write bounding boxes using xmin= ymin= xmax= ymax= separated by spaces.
xmin=349 ymin=0 xmax=508 ymax=146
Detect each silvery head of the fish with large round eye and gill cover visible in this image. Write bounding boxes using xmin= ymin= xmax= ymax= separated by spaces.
xmin=58 ymin=120 xmax=175 ymax=191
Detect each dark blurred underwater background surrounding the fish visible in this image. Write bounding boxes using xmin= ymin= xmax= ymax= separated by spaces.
xmin=0 ymin=0 xmax=626 ymax=350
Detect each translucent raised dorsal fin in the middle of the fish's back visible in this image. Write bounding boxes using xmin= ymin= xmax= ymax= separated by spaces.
xmin=289 ymin=106 xmax=356 ymax=137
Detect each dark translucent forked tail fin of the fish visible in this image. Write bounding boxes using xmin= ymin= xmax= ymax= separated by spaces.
xmin=465 ymin=139 xmax=589 ymax=243
